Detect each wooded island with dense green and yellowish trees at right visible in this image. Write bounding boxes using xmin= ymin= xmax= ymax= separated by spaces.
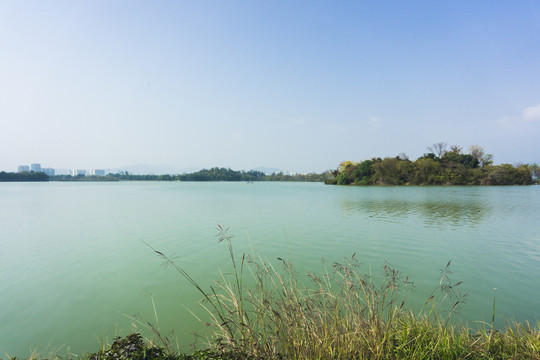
xmin=325 ymin=142 xmax=540 ymax=185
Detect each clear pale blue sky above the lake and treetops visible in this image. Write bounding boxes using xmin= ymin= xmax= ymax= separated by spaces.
xmin=0 ymin=0 xmax=540 ymax=172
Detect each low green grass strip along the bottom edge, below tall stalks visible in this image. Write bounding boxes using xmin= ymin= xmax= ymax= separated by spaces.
xmin=84 ymin=317 xmax=540 ymax=360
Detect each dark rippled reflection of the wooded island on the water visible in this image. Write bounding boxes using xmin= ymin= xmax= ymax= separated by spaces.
xmin=341 ymin=195 xmax=492 ymax=226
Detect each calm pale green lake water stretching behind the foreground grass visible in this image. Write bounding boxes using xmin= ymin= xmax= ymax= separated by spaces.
xmin=0 ymin=182 xmax=540 ymax=357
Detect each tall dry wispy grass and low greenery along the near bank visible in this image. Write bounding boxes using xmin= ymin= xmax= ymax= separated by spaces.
xmin=5 ymin=226 xmax=540 ymax=360
